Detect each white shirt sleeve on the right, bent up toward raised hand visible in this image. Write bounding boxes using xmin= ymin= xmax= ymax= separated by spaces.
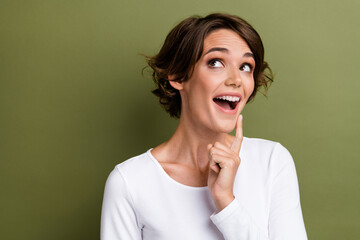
xmin=210 ymin=144 xmax=307 ymax=240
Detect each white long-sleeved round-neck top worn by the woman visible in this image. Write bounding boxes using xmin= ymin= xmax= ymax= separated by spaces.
xmin=101 ymin=137 xmax=307 ymax=240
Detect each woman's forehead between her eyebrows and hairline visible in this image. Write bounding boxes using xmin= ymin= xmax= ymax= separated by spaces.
xmin=203 ymin=29 xmax=251 ymax=53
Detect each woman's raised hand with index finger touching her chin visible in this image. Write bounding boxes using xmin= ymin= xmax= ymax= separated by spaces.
xmin=208 ymin=115 xmax=243 ymax=212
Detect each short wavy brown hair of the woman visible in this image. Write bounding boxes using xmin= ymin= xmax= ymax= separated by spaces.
xmin=147 ymin=13 xmax=273 ymax=118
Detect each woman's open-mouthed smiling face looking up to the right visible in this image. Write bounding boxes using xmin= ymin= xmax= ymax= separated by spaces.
xmin=170 ymin=29 xmax=255 ymax=133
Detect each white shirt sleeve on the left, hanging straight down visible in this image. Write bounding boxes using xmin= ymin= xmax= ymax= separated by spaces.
xmin=100 ymin=168 xmax=142 ymax=240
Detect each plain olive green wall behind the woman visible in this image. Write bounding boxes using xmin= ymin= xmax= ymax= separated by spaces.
xmin=0 ymin=0 xmax=360 ymax=240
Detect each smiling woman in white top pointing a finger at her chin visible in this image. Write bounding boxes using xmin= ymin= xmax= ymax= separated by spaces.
xmin=101 ymin=14 xmax=307 ymax=240
